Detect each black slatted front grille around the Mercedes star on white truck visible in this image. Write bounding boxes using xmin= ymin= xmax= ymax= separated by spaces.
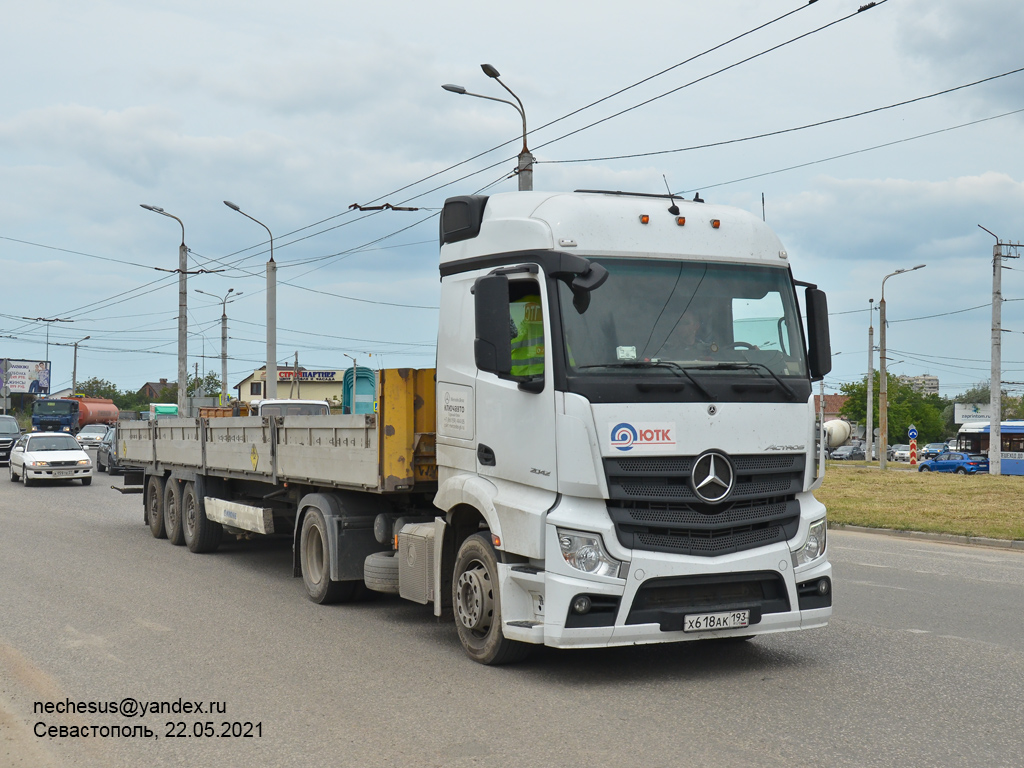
xmin=604 ymin=454 xmax=805 ymax=557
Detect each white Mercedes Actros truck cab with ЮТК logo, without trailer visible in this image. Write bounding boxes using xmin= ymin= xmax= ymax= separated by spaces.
xmin=434 ymin=193 xmax=831 ymax=664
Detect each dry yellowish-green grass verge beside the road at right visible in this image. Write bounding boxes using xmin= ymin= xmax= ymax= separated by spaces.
xmin=814 ymin=462 xmax=1024 ymax=540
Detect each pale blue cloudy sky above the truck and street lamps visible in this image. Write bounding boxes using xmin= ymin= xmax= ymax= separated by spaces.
xmin=0 ymin=0 xmax=1024 ymax=397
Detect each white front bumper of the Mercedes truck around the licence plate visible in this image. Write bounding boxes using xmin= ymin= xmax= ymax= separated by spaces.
xmin=500 ymin=494 xmax=831 ymax=648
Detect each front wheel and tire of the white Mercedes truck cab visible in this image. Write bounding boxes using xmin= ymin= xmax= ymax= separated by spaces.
xmin=452 ymin=534 xmax=529 ymax=665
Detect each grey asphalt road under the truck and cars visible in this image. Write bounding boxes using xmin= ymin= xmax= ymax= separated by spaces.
xmin=0 ymin=467 xmax=1024 ymax=768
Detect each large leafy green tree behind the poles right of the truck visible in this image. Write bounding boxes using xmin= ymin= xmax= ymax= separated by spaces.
xmin=840 ymin=372 xmax=955 ymax=444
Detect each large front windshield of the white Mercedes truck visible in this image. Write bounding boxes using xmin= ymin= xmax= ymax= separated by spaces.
xmin=558 ymin=259 xmax=807 ymax=378
